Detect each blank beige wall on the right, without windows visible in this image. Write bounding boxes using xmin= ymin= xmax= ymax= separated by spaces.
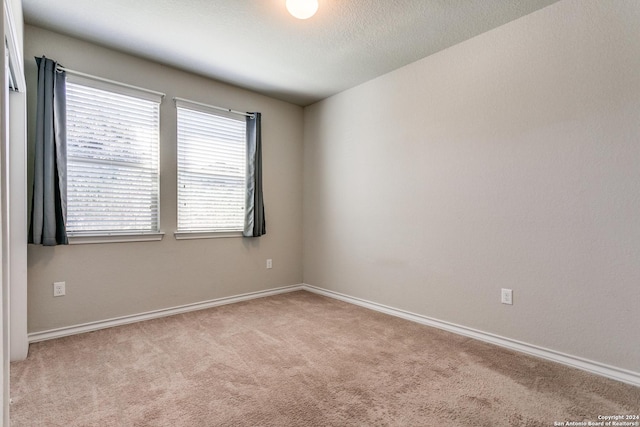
xmin=304 ymin=0 xmax=640 ymax=372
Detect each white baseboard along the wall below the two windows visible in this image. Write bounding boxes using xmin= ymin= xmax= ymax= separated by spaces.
xmin=28 ymin=285 xmax=302 ymax=343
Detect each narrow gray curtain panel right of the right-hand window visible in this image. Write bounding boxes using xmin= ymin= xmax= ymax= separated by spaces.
xmin=243 ymin=113 xmax=267 ymax=237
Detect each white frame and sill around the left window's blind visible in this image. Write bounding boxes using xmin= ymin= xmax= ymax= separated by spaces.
xmin=65 ymin=73 xmax=165 ymax=245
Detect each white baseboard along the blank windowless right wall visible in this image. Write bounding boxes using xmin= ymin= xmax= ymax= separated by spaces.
xmin=302 ymin=284 xmax=640 ymax=387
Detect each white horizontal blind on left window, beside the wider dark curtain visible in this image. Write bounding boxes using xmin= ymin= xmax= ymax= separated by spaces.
xmin=67 ymin=81 xmax=161 ymax=235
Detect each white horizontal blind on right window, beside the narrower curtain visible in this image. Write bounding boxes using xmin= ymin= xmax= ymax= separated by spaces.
xmin=176 ymin=100 xmax=246 ymax=232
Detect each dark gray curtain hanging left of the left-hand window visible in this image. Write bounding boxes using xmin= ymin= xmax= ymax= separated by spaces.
xmin=29 ymin=56 xmax=69 ymax=246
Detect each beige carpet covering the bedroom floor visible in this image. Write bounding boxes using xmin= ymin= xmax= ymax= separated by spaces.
xmin=11 ymin=292 xmax=640 ymax=427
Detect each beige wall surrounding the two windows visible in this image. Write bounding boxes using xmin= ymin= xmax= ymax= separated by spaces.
xmin=25 ymin=26 xmax=303 ymax=332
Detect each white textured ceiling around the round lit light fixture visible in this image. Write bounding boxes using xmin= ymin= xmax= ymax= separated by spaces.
xmin=22 ymin=0 xmax=557 ymax=106
